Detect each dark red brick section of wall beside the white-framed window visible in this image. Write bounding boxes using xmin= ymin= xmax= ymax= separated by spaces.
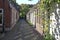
xmin=0 ymin=0 xmax=11 ymax=27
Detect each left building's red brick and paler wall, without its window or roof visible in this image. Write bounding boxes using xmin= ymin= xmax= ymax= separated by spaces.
xmin=0 ymin=0 xmax=19 ymax=31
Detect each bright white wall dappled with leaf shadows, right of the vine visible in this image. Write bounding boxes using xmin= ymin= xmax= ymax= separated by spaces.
xmin=50 ymin=4 xmax=60 ymax=40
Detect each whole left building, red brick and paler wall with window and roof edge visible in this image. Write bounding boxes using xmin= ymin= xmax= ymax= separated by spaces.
xmin=0 ymin=0 xmax=19 ymax=31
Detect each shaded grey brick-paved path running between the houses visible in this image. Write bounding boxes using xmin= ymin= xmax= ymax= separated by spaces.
xmin=0 ymin=19 xmax=43 ymax=40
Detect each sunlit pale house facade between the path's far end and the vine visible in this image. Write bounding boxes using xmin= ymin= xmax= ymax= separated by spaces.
xmin=26 ymin=6 xmax=43 ymax=35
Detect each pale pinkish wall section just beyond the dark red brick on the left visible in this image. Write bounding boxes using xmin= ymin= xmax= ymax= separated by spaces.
xmin=10 ymin=4 xmax=19 ymax=27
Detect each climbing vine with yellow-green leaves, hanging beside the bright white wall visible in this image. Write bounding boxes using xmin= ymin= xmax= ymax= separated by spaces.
xmin=37 ymin=0 xmax=60 ymax=40
